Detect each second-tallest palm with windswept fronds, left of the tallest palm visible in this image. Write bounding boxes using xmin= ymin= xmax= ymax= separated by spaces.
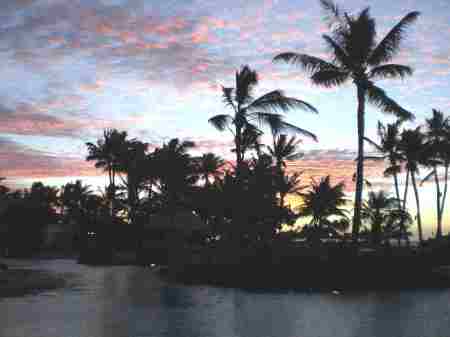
xmin=209 ymin=66 xmax=317 ymax=177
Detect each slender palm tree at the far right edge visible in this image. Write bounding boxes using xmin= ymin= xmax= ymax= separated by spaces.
xmin=422 ymin=109 xmax=450 ymax=238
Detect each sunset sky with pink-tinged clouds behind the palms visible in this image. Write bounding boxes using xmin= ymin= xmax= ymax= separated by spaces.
xmin=0 ymin=0 xmax=450 ymax=236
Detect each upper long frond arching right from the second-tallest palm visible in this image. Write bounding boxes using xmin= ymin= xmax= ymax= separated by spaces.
xmin=246 ymin=90 xmax=317 ymax=113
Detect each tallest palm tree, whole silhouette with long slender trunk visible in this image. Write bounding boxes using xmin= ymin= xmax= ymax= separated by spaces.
xmin=274 ymin=0 xmax=419 ymax=242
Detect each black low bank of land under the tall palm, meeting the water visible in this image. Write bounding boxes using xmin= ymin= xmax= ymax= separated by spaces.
xmin=160 ymin=243 xmax=450 ymax=291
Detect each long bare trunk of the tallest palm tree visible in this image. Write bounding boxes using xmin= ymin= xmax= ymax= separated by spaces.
xmin=352 ymin=84 xmax=366 ymax=243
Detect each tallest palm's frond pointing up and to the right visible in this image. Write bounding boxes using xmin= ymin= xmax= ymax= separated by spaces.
xmin=368 ymin=12 xmax=420 ymax=66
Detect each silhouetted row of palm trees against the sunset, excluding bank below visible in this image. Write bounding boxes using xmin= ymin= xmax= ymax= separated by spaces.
xmin=3 ymin=0 xmax=450 ymax=258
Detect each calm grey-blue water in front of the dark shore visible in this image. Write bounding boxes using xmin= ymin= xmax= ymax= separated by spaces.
xmin=0 ymin=260 xmax=450 ymax=337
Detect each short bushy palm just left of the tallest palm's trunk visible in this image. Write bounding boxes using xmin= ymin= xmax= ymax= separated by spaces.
xmin=299 ymin=176 xmax=347 ymax=241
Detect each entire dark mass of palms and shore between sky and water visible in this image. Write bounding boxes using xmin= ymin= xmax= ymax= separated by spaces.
xmin=0 ymin=0 xmax=450 ymax=290
